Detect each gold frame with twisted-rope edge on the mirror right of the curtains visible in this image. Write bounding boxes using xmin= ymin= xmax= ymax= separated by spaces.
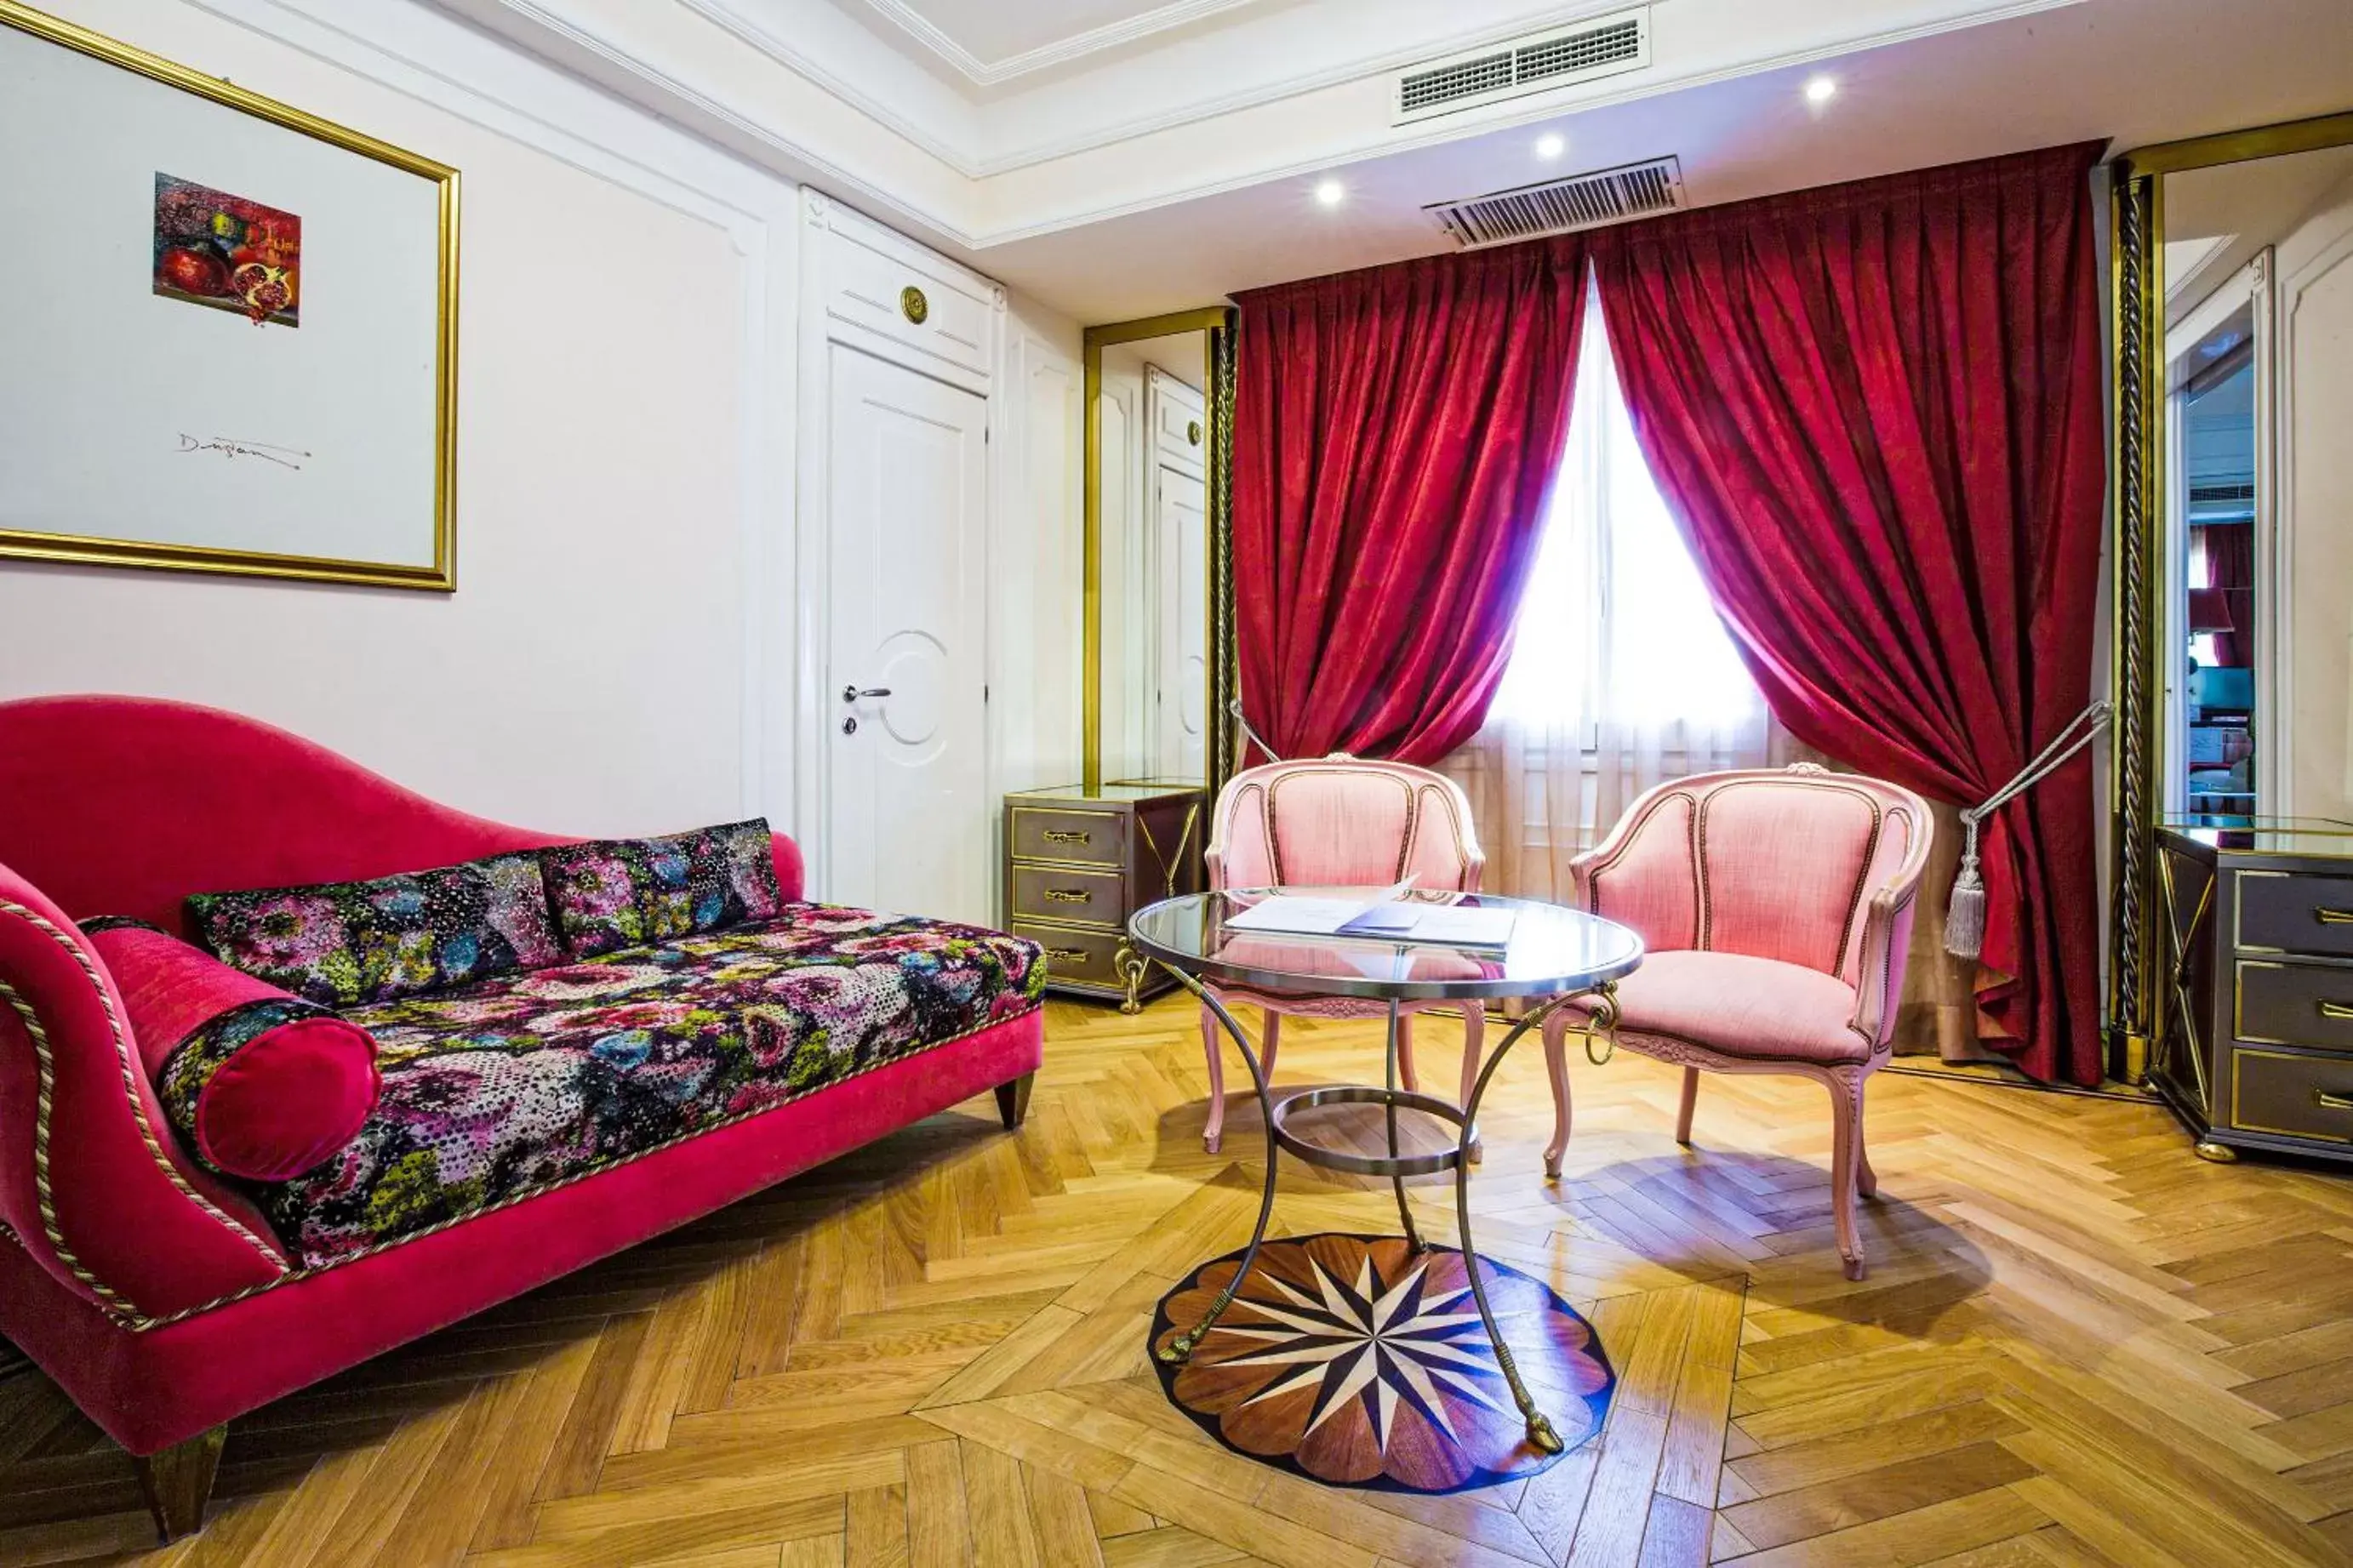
xmin=2108 ymin=113 xmax=2353 ymax=1084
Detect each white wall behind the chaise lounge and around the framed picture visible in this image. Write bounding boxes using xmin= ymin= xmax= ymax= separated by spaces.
xmin=0 ymin=0 xmax=1077 ymax=870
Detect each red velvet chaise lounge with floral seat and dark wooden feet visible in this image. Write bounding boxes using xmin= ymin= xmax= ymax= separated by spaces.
xmin=0 ymin=696 xmax=1042 ymax=1540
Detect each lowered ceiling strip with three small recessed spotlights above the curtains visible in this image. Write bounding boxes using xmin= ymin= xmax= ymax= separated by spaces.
xmin=976 ymin=0 xmax=2353 ymax=322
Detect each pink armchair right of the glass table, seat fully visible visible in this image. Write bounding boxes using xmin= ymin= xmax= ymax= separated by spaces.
xmin=1544 ymin=764 xmax=1934 ymax=1279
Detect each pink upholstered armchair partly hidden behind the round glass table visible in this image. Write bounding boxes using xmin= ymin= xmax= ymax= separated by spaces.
xmin=1200 ymin=752 xmax=1487 ymax=1155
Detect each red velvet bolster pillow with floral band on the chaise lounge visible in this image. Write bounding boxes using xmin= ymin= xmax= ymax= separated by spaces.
xmin=85 ymin=921 xmax=381 ymax=1183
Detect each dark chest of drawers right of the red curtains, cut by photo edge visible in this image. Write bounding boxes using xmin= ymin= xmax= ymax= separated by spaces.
xmin=2150 ymin=820 xmax=2353 ymax=1164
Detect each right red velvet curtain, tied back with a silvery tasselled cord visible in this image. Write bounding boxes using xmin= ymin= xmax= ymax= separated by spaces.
xmin=1596 ymin=144 xmax=2106 ymax=1084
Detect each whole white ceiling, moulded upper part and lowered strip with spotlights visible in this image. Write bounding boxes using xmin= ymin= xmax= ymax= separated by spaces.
xmin=440 ymin=0 xmax=2353 ymax=322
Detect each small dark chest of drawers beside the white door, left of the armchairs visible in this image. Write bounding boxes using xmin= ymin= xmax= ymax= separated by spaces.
xmin=1005 ymin=783 xmax=1209 ymax=1013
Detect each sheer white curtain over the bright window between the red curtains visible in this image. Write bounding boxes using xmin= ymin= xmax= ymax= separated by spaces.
xmin=1440 ymin=276 xmax=1797 ymax=900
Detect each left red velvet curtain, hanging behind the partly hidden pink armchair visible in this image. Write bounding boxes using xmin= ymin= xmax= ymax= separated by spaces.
xmin=1233 ymin=235 xmax=1586 ymax=764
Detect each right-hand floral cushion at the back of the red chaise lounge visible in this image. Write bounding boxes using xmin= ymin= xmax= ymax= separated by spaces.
xmin=539 ymin=816 xmax=784 ymax=959
